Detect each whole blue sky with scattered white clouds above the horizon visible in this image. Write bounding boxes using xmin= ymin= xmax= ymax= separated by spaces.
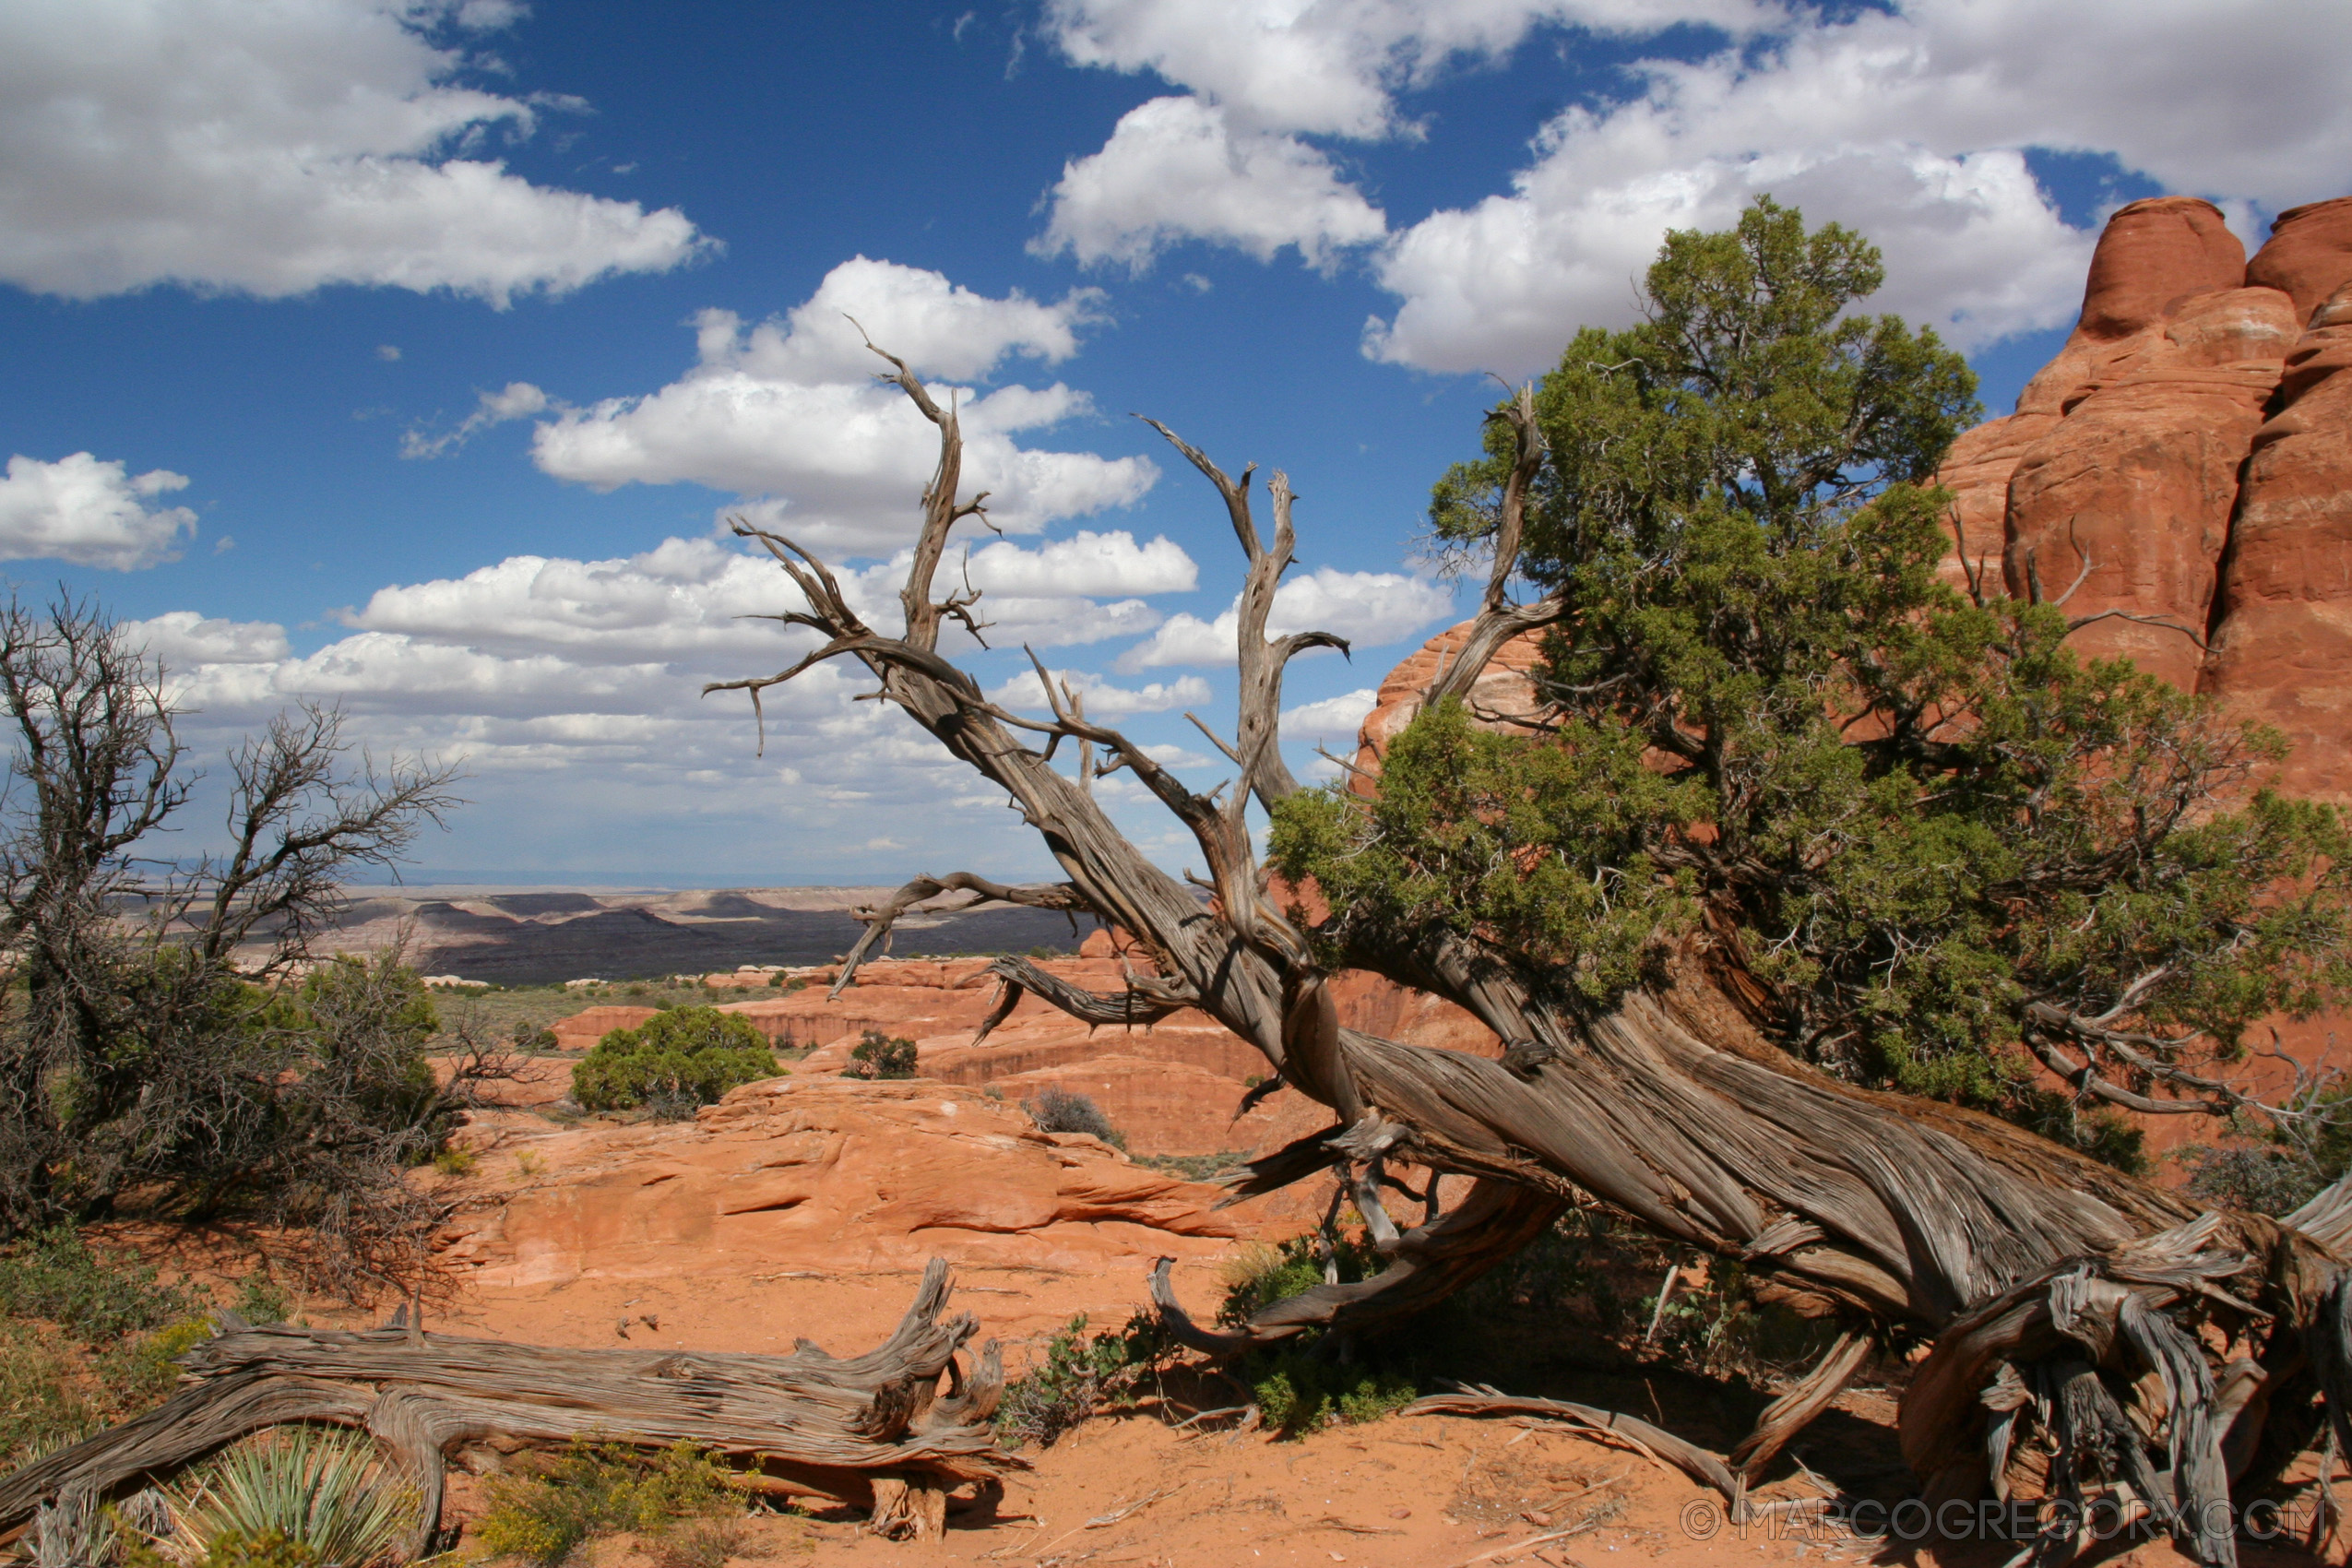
xmin=0 ymin=0 xmax=2352 ymax=884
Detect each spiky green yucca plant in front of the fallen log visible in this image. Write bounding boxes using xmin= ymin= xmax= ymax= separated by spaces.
xmin=172 ymin=1427 xmax=419 ymax=1568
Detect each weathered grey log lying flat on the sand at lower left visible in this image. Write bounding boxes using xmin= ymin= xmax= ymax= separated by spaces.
xmin=0 ymin=1260 xmax=1028 ymax=1556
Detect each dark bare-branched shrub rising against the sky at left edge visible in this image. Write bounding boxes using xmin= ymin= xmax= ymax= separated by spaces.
xmin=0 ymin=600 xmax=472 ymax=1307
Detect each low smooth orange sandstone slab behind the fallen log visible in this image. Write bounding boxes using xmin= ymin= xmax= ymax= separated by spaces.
xmin=445 ymin=1075 xmax=1256 ymax=1286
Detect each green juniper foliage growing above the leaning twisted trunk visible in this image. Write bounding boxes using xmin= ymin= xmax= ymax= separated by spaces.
xmin=1273 ymin=197 xmax=2352 ymax=1166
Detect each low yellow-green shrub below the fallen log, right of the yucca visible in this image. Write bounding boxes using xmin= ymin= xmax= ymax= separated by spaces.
xmin=475 ymin=1439 xmax=743 ymax=1568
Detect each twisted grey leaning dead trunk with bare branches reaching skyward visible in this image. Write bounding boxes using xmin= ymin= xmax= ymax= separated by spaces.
xmin=708 ymin=350 xmax=2352 ymax=1563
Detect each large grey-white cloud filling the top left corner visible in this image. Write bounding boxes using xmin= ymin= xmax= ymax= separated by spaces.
xmin=0 ymin=0 xmax=706 ymax=305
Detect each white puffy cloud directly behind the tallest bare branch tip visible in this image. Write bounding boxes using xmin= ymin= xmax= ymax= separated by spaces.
xmin=531 ymin=256 xmax=1159 ymax=554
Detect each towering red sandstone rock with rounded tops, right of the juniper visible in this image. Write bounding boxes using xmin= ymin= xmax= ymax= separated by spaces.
xmin=1942 ymin=197 xmax=2352 ymax=800
